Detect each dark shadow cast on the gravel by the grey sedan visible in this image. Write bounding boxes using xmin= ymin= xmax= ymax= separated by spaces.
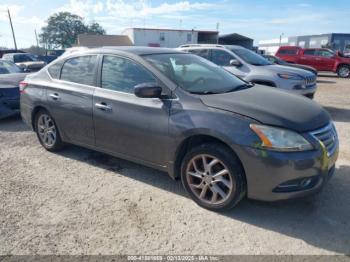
xmin=56 ymin=146 xmax=350 ymax=254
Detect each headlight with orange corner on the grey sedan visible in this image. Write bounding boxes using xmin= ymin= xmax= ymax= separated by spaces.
xmin=250 ymin=124 xmax=313 ymax=151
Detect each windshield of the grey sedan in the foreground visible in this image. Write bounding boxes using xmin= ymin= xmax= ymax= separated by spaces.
xmin=144 ymin=54 xmax=250 ymax=94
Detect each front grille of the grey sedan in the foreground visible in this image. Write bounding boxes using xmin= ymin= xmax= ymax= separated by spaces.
xmin=311 ymin=123 xmax=338 ymax=156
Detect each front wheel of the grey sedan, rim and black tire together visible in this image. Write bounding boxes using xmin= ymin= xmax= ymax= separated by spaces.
xmin=181 ymin=143 xmax=246 ymax=211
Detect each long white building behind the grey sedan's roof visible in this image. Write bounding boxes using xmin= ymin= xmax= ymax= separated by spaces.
xmin=122 ymin=28 xmax=218 ymax=48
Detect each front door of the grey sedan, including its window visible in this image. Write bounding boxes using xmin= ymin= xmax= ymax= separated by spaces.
xmin=93 ymin=55 xmax=170 ymax=165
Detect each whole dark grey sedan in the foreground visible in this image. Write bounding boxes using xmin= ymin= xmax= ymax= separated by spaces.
xmin=21 ymin=47 xmax=338 ymax=210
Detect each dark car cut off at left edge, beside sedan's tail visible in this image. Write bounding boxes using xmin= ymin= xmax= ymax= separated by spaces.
xmin=0 ymin=59 xmax=27 ymax=119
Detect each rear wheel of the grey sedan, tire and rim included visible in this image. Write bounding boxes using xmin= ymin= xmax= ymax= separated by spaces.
xmin=35 ymin=110 xmax=64 ymax=152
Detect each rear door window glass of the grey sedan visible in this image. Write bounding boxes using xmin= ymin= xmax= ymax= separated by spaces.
xmin=61 ymin=55 xmax=97 ymax=86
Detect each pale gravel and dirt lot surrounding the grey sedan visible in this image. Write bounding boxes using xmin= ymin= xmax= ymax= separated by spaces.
xmin=0 ymin=76 xmax=350 ymax=255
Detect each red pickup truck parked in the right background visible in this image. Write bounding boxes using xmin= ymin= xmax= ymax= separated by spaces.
xmin=276 ymin=46 xmax=350 ymax=78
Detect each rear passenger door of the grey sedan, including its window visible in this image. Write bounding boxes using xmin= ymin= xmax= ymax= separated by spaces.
xmin=47 ymin=55 xmax=97 ymax=145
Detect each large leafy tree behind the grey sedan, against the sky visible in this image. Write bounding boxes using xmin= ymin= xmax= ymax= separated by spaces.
xmin=39 ymin=12 xmax=106 ymax=48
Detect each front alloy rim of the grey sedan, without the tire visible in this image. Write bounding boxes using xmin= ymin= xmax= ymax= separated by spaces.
xmin=186 ymin=154 xmax=235 ymax=205
